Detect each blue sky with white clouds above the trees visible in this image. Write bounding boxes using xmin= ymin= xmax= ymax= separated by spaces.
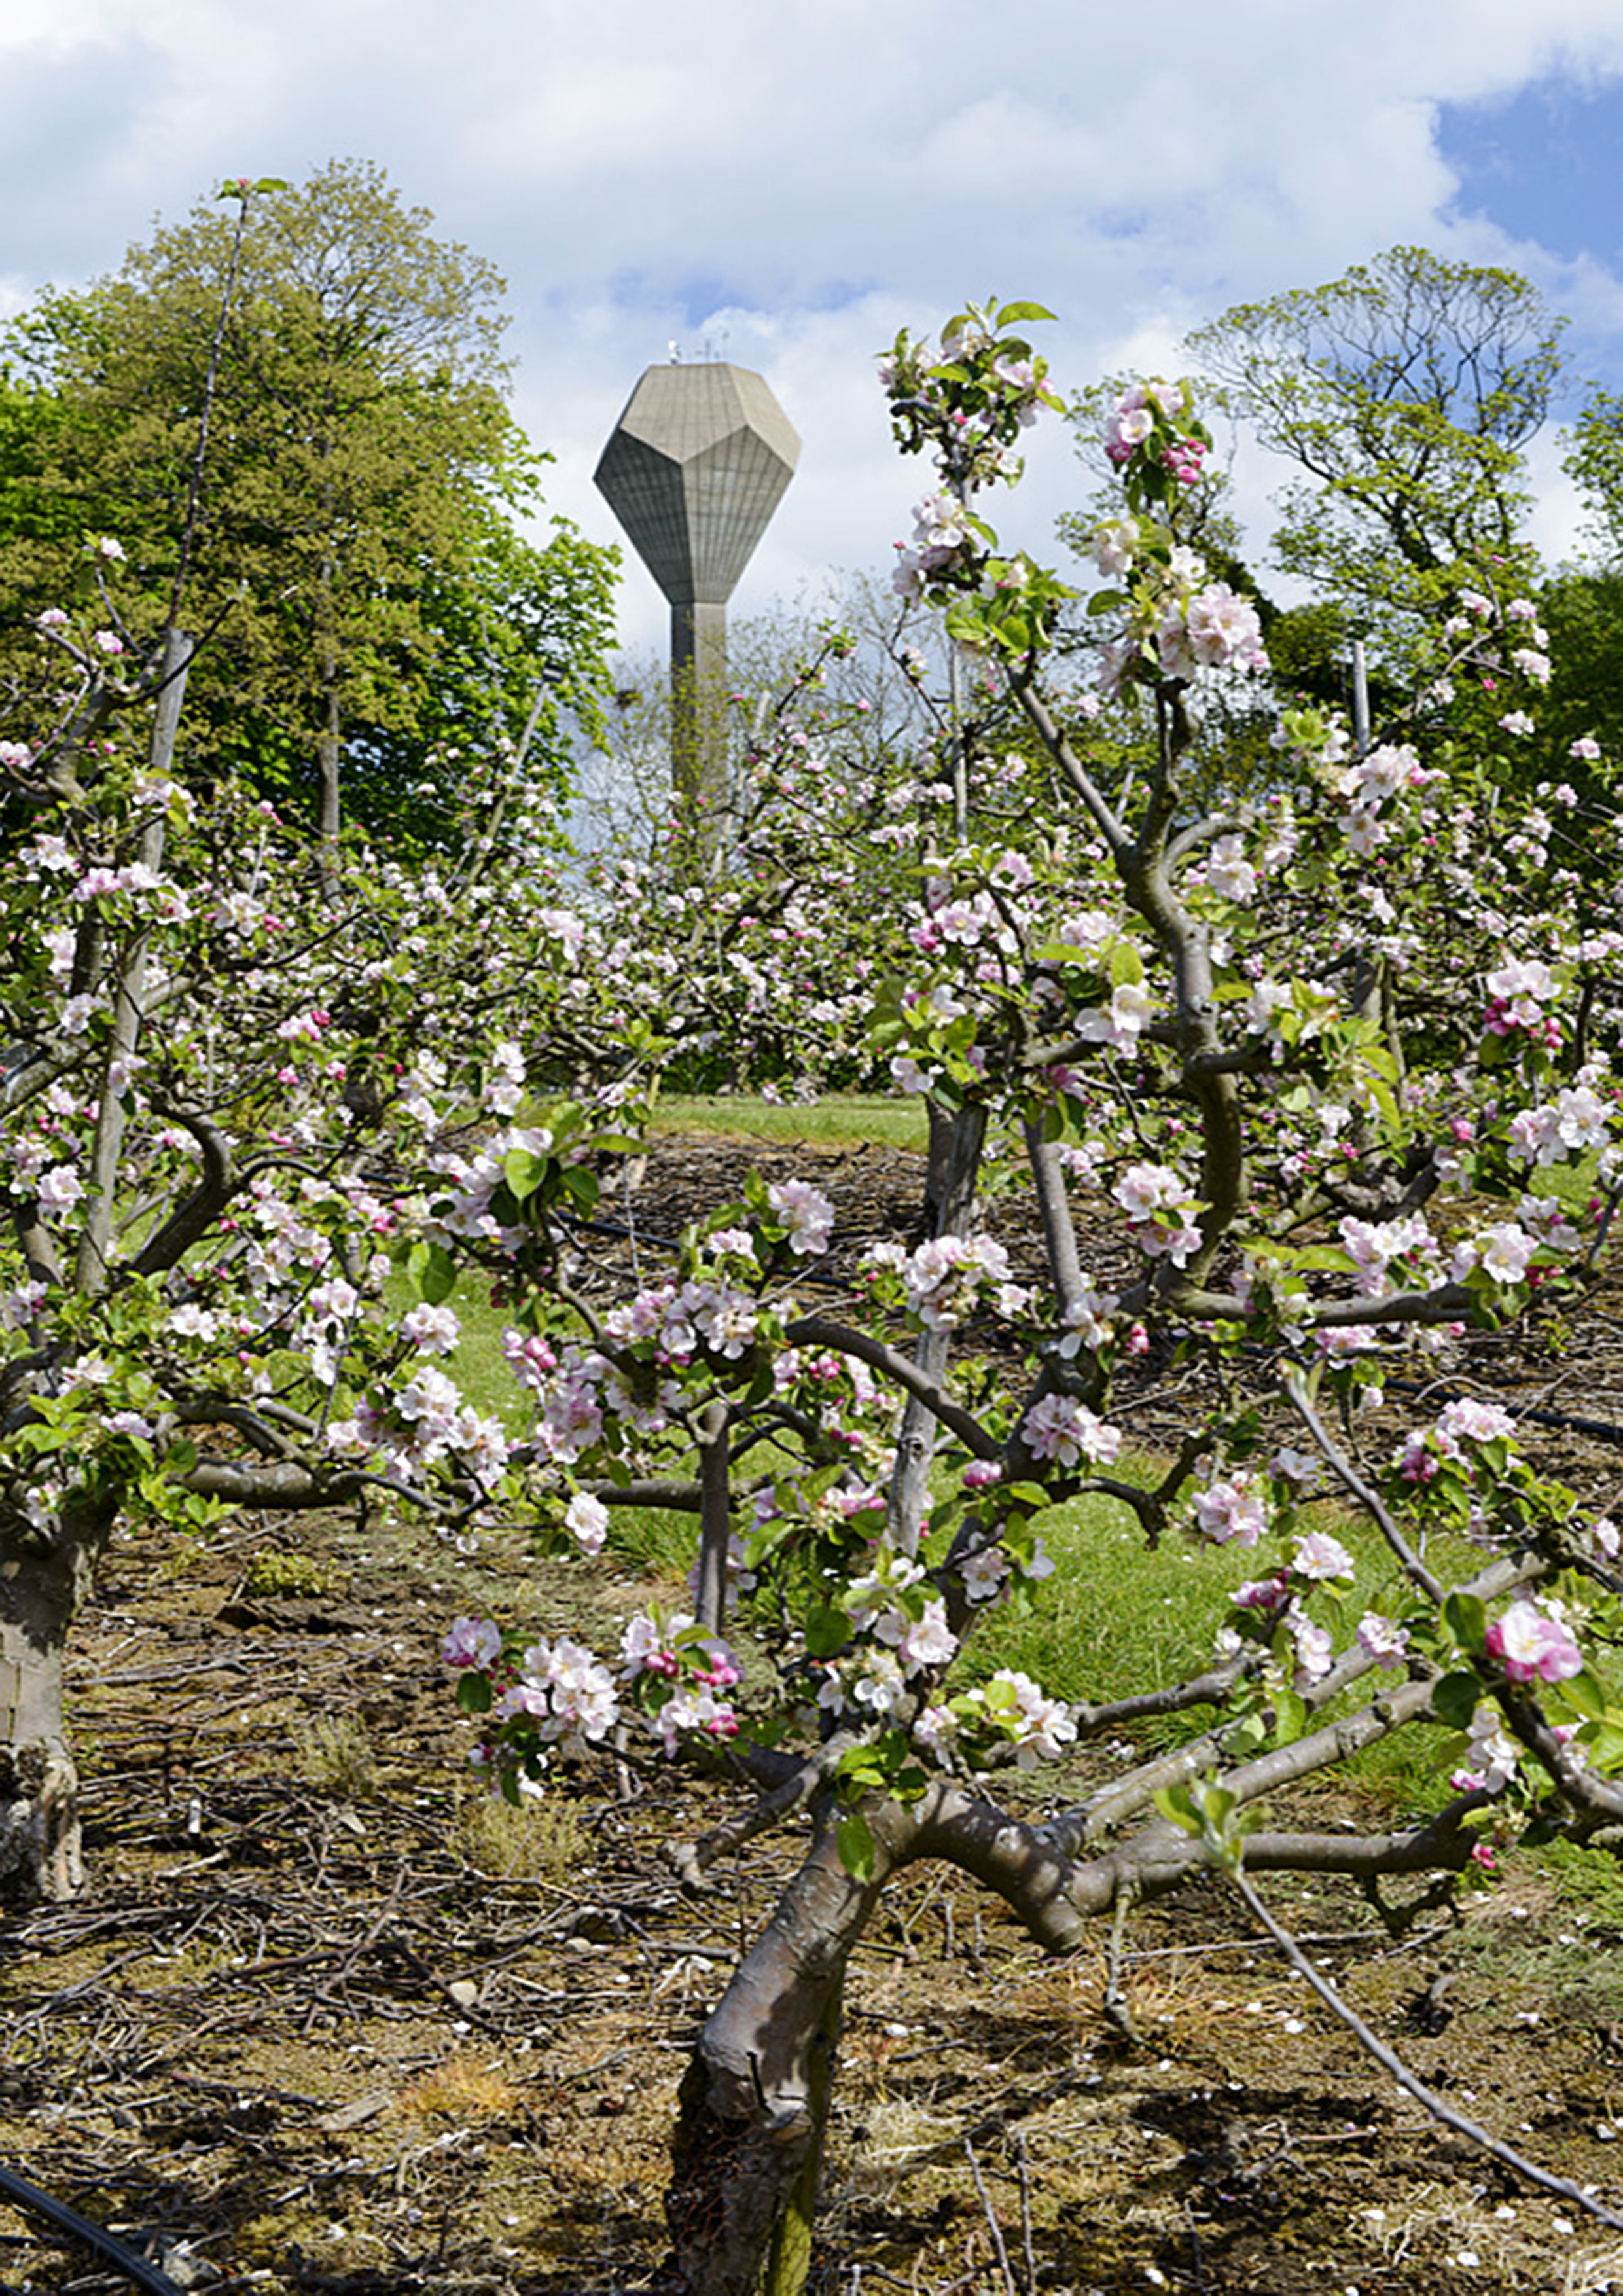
xmin=0 ymin=0 xmax=1623 ymax=647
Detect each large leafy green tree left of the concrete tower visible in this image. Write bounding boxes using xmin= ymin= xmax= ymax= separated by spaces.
xmin=0 ymin=161 xmax=613 ymax=863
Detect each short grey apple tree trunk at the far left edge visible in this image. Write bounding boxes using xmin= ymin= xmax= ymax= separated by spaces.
xmin=0 ymin=1501 xmax=113 ymax=1908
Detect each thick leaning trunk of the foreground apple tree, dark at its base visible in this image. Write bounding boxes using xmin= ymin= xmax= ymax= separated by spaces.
xmin=666 ymin=1804 xmax=914 ymax=2296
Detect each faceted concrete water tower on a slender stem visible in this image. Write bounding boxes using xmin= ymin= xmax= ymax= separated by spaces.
xmin=597 ymin=361 xmax=801 ymax=852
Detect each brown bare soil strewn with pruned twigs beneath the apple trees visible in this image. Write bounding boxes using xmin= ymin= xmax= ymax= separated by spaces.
xmin=0 ymin=1145 xmax=1623 ymax=2296
